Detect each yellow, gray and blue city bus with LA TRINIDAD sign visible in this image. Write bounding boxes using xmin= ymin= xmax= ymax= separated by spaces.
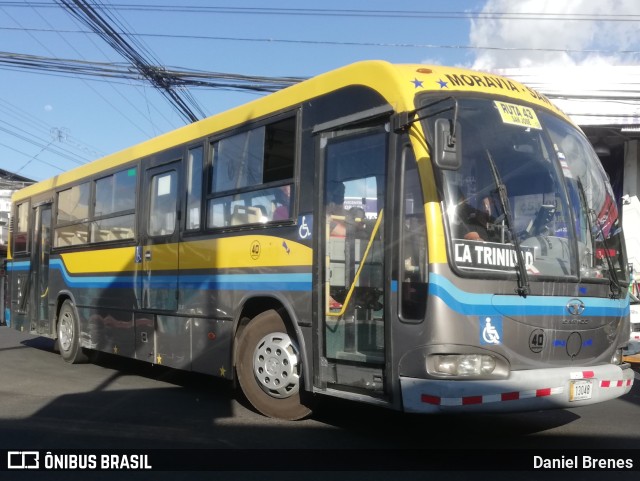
xmin=7 ymin=61 xmax=633 ymax=419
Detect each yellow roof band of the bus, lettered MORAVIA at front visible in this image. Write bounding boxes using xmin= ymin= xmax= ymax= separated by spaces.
xmin=13 ymin=60 xmax=568 ymax=201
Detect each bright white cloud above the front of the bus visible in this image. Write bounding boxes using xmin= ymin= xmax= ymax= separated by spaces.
xmin=469 ymin=0 xmax=640 ymax=70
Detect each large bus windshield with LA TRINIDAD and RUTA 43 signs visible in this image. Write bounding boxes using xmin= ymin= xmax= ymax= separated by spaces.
xmin=421 ymin=97 xmax=626 ymax=284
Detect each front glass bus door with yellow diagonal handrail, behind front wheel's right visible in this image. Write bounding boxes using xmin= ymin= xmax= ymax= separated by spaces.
xmin=320 ymin=125 xmax=388 ymax=396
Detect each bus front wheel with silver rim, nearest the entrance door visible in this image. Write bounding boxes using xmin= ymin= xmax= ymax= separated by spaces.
xmin=236 ymin=310 xmax=311 ymax=421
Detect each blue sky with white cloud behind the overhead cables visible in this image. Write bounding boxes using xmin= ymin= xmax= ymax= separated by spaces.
xmin=0 ymin=0 xmax=640 ymax=180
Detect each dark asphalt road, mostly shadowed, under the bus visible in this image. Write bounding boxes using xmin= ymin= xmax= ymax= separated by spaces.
xmin=0 ymin=327 xmax=640 ymax=476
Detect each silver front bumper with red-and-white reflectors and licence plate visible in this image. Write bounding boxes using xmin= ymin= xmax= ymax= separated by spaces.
xmin=400 ymin=364 xmax=634 ymax=413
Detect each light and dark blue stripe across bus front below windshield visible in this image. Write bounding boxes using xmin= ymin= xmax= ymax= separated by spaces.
xmin=429 ymin=273 xmax=629 ymax=317
